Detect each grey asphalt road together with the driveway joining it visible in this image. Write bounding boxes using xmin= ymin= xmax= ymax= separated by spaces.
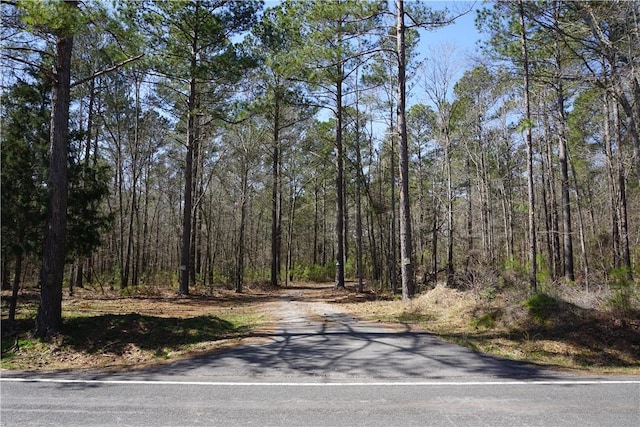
xmin=0 ymin=294 xmax=640 ymax=426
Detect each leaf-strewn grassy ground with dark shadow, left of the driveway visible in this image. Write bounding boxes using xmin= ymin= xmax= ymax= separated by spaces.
xmin=1 ymin=290 xmax=270 ymax=370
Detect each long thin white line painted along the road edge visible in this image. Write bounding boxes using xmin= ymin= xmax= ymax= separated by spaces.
xmin=0 ymin=378 xmax=640 ymax=387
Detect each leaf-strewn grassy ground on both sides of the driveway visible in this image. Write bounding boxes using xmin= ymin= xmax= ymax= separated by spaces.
xmin=0 ymin=283 xmax=640 ymax=375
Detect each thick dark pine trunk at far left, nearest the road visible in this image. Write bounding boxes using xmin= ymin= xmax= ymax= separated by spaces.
xmin=34 ymin=5 xmax=77 ymax=337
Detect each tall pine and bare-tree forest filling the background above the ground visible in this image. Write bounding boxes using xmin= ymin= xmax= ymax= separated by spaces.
xmin=0 ymin=0 xmax=640 ymax=342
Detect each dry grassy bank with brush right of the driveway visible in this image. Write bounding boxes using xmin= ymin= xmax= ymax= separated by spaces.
xmin=345 ymin=285 xmax=640 ymax=374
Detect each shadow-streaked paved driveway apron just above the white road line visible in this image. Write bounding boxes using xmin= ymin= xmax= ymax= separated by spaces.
xmin=117 ymin=321 xmax=556 ymax=381
